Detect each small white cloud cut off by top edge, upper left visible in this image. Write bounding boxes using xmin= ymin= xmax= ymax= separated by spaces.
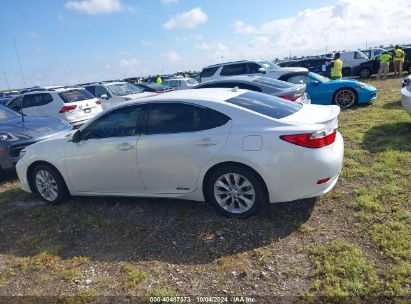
xmin=65 ymin=0 xmax=135 ymax=15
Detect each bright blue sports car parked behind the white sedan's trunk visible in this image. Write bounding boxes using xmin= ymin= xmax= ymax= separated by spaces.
xmin=279 ymin=71 xmax=377 ymax=109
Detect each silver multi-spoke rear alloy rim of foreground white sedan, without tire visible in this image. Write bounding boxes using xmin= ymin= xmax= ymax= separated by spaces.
xmin=214 ymin=173 xmax=256 ymax=214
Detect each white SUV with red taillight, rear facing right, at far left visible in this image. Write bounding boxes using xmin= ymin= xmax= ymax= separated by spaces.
xmin=6 ymin=88 xmax=103 ymax=127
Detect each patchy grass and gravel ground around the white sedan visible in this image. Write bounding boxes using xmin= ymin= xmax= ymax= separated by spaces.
xmin=0 ymin=79 xmax=411 ymax=303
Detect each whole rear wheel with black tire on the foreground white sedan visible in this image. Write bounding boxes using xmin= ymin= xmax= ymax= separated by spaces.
xmin=204 ymin=165 xmax=267 ymax=218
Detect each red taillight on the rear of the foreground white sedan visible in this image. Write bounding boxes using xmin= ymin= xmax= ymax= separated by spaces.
xmin=280 ymin=129 xmax=337 ymax=149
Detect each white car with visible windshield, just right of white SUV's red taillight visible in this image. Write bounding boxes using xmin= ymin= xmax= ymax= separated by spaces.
xmin=84 ymin=82 xmax=155 ymax=110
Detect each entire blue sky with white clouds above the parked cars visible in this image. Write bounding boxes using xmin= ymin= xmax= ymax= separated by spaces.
xmin=0 ymin=0 xmax=411 ymax=89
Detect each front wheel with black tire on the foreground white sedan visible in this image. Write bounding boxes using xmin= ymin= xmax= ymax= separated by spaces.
xmin=30 ymin=164 xmax=70 ymax=204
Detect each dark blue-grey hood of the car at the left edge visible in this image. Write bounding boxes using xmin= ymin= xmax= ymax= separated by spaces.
xmin=0 ymin=116 xmax=71 ymax=139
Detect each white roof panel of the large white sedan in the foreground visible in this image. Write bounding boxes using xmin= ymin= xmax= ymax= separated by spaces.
xmin=122 ymin=88 xmax=248 ymax=104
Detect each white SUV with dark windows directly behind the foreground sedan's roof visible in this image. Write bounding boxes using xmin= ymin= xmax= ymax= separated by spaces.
xmin=200 ymin=60 xmax=308 ymax=82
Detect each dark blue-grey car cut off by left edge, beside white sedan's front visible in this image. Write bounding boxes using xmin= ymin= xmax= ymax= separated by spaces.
xmin=0 ymin=105 xmax=71 ymax=175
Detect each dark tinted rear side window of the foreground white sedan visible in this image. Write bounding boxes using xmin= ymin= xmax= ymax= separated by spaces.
xmin=146 ymin=103 xmax=230 ymax=135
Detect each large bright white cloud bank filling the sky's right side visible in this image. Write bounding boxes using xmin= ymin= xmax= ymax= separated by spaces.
xmin=233 ymin=0 xmax=411 ymax=57
